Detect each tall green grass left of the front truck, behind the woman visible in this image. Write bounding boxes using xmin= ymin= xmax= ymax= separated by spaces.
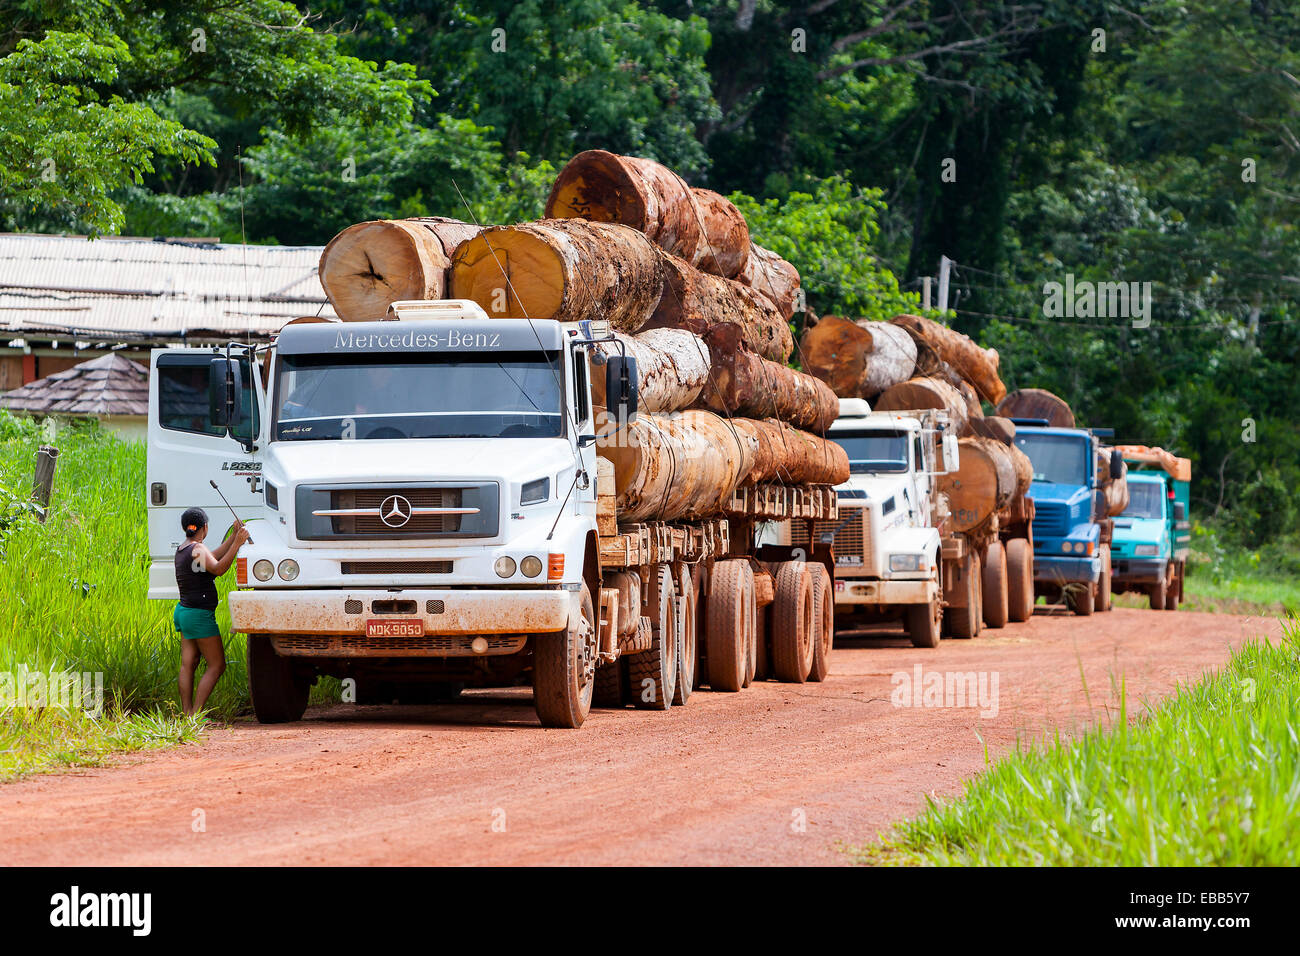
xmin=0 ymin=411 xmax=338 ymax=779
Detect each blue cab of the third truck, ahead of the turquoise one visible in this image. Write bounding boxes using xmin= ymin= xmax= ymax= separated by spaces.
xmin=1011 ymin=419 xmax=1125 ymax=615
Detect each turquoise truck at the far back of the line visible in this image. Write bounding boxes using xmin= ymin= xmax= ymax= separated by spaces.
xmin=1110 ymin=445 xmax=1192 ymax=611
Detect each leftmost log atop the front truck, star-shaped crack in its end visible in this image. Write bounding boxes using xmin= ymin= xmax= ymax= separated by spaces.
xmin=319 ymin=217 xmax=482 ymax=321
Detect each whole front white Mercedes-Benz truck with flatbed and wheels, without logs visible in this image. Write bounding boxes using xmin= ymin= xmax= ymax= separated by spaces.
xmin=147 ymin=300 xmax=839 ymax=727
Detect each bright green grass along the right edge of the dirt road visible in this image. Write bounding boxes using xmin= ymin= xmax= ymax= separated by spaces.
xmin=848 ymin=617 xmax=1300 ymax=866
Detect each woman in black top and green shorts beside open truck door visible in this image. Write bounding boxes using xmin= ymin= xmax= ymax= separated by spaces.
xmin=172 ymin=507 xmax=248 ymax=715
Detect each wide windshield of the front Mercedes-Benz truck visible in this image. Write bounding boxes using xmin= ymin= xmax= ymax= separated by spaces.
xmin=276 ymin=352 xmax=562 ymax=441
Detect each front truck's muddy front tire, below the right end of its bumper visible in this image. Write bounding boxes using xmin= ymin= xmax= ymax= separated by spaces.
xmin=532 ymin=581 xmax=597 ymax=730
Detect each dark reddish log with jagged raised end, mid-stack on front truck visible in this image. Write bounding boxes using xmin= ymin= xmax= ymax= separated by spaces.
xmin=699 ymin=323 xmax=840 ymax=434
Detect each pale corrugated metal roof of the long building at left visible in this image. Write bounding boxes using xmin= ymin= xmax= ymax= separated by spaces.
xmin=0 ymin=234 xmax=334 ymax=339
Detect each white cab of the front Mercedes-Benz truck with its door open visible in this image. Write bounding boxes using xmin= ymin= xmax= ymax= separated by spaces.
xmin=147 ymin=300 xmax=634 ymax=722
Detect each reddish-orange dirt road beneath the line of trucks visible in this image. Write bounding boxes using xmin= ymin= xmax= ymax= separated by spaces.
xmin=0 ymin=609 xmax=1279 ymax=865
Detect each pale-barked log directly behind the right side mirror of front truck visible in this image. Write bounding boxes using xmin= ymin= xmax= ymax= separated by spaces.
xmin=590 ymin=329 xmax=710 ymax=415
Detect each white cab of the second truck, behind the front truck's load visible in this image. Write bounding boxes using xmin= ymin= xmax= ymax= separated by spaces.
xmin=794 ymin=398 xmax=957 ymax=646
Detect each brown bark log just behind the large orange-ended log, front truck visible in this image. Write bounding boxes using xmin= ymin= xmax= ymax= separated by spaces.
xmin=646 ymin=252 xmax=794 ymax=362
